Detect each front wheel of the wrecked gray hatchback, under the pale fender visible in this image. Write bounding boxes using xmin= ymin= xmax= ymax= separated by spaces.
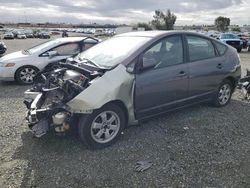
xmin=78 ymin=103 xmax=126 ymax=149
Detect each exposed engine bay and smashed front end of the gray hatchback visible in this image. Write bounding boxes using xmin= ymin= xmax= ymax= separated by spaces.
xmin=24 ymin=64 xmax=104 ymax=137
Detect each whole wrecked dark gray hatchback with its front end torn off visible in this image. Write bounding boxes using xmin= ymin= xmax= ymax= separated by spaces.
xmin=24 ymin=31 xmax=241 ymax=148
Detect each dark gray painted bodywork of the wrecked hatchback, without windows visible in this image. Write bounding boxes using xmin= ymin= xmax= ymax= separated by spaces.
xmin=122 ymin=31 xmax=241 ymax=119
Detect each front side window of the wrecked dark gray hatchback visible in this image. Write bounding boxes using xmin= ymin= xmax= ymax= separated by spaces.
xmin=143 ymin=36 xmax=183 ymax=68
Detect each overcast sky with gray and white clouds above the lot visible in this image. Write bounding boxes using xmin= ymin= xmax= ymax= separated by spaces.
xmin=0 ymin=0 xmax=250 ymax=25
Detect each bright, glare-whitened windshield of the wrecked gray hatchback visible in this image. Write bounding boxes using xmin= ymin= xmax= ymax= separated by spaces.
xmin=78 ymin=37 xmax=151 ymax=68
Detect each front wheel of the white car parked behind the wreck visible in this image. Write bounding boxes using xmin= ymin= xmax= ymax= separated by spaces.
xmin=15 ymin=66 xmax=39 ymax=85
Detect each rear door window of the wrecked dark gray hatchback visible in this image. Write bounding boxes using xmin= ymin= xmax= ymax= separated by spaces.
xmin=187 ymin=36 xmax=216 ymax=61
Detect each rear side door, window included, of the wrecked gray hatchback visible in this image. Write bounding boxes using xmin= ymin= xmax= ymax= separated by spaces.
xmin=186 ymin=35 xmax=225 ymax=99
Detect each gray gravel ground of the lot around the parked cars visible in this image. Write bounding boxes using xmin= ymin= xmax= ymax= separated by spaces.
xmin=0 ymin=39 xmax=250 ymax=188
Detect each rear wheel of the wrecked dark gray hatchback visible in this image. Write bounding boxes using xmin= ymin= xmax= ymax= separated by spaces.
xmin=213 ymin=80 xmax=233 ymax=107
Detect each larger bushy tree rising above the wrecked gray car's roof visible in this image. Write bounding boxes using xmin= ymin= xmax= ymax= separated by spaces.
xmin=151 ymin=9 xmax=177 ymax=30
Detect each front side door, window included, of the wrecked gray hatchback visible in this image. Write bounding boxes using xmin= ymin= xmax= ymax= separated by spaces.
xmin=135 ymin=35 xmax=188 ymax=119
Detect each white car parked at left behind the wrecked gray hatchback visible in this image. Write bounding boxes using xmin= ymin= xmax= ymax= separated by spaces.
xmin=0 ymin=37 xmax=99 ymax=84
